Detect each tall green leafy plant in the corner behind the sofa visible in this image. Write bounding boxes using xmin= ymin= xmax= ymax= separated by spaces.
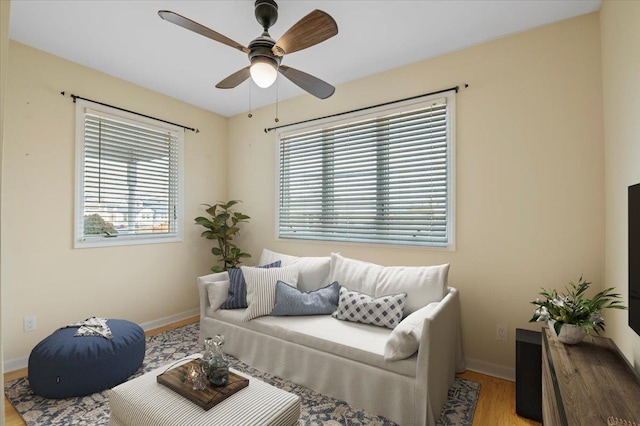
xmin=195 ymin=200 xmax=251 ymax=272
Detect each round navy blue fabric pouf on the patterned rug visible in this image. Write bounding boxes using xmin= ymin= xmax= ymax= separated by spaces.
xmin=29 ymin=319 xmax=145 ymax=398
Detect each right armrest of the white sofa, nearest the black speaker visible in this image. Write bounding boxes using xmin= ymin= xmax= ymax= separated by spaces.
xmin=416 ymin=287 xmax=465 ymax=426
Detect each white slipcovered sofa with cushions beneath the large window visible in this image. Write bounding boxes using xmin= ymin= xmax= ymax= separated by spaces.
xmin=198 ymin=250 xmax=464 ymax=426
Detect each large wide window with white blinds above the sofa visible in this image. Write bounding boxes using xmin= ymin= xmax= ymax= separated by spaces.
xmin=278 ymin=91 xmax=455 ymax=249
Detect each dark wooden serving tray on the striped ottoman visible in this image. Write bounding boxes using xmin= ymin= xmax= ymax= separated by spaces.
xmin=157 ymin=359 xmax=249 ymax=410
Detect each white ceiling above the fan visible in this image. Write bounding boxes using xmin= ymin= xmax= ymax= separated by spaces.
xmin=10 ymin=0 xmax=600 ymax=116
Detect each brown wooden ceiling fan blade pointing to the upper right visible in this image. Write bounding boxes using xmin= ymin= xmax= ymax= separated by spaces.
xmin=271 ymin=9 xmax=338 ymax=56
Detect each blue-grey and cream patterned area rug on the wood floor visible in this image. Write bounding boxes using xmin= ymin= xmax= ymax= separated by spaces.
xmin=5 ymin=324 xmax=480 ymax=426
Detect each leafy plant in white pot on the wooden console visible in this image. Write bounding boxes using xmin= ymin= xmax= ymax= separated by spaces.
xmin=529 ymin=276 xmax=627 ymax=344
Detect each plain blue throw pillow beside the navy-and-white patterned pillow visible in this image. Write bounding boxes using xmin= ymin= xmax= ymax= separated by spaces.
xmin=271 ymin=281 xmax=340 ymax=316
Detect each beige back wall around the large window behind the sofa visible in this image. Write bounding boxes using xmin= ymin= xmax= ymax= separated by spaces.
xmin=228 ymin=13 xmax=604 ymax=377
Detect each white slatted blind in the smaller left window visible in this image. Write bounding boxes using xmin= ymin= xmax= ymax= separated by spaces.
xmin=79 ymin=109 xmax=179 ymax=238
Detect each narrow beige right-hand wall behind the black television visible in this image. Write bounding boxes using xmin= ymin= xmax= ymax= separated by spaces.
xmin=600 ymin=0 xmax=640 ymax=371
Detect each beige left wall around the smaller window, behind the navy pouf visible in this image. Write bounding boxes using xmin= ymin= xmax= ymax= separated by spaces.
xmin=2 ymin=41 xmax=227 ymax=362
